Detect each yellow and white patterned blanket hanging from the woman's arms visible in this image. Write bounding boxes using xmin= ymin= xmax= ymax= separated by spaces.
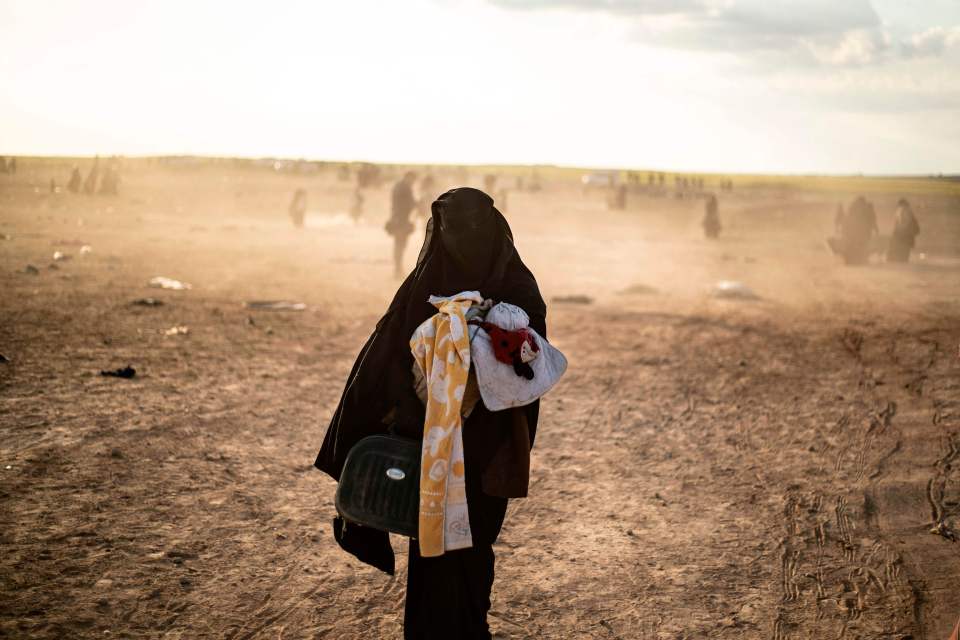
xmin=410 ymin=291 xmax=483 ymax=557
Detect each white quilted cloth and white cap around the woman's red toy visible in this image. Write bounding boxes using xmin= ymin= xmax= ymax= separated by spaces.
xmin=470 ymin=302 xmax=567 ymax=411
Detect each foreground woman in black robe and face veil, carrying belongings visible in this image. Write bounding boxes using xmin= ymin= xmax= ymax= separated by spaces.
xmin=315 ymin=187 xmax=546 ymax=638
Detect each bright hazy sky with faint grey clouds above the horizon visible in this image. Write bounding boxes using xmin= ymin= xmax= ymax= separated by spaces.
xmin=0 ymin=0 xmax=960 ymax=173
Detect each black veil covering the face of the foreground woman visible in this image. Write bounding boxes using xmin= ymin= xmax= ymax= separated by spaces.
xmin=440 ymin=206 xmax=496 ymax=282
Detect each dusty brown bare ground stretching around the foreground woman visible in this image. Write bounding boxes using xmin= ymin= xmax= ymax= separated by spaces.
xmin=0 ymin=161 xmax=960 ymax=640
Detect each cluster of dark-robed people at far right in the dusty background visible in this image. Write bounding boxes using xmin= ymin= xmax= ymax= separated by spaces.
xmin=827 ymin=196 xmax=920 ymax=264
